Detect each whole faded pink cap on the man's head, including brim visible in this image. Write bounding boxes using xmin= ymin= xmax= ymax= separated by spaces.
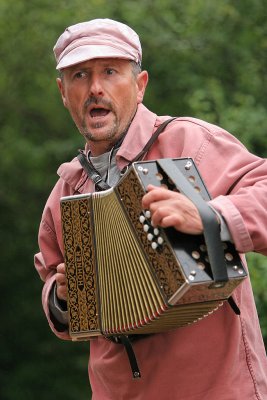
xmin=54 ymin=19 xmax=142 ymax=69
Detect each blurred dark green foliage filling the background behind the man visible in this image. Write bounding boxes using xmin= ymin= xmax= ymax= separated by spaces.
xmin=0 ymin=0 xmax=267 ymax=400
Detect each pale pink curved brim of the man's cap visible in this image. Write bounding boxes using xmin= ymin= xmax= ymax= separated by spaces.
xmin=56 ymin=45 xmax=135 ymax=69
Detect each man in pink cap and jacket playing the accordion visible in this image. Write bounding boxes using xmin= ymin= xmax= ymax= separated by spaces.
xmin=35 ymin=19 xmax=267 ymax=400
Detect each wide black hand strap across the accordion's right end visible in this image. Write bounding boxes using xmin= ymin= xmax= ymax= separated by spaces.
xmin=157 ymin=158 xmax=229 ymax=287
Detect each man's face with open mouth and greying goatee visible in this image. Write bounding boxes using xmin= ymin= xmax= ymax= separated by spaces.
xmin=57 ymin=59 xmax=147 ymax=155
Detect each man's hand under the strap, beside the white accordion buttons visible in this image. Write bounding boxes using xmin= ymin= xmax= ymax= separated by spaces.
xmin=142 ymin=185 xmax=203 ymax=235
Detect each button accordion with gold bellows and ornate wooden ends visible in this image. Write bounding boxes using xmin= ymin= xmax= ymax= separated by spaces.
xmin=60 ymin=158 xmax=247 ymax=340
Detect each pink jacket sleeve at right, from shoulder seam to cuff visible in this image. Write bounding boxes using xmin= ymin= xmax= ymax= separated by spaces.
xmin=199 ymin=126 xmax=267 ymax=255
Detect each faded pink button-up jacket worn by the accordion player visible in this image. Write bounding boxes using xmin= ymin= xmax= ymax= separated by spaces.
xmin=35 ymin=105 xmax=267 ymax=400
